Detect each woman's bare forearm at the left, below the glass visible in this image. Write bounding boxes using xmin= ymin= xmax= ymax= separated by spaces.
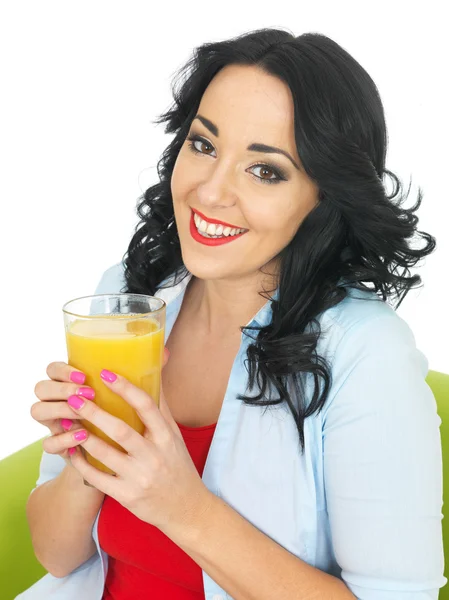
xmin=26 ymin=454 xmax=104 ymax=577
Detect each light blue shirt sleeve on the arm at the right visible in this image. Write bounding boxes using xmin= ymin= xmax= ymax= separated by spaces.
xmin=323 ymin=312 xmax=447 ymax=600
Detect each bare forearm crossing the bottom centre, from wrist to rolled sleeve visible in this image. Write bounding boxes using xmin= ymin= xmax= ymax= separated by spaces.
xmin=160 ymin=492 xmax=355 ymax=600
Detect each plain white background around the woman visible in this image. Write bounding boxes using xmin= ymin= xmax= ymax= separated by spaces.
xmin=0 ymin=0 xmax=449 ymax=459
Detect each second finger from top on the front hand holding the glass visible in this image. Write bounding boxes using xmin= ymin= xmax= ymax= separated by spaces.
xmin=67 ymin=384 xmax=149 ymax=456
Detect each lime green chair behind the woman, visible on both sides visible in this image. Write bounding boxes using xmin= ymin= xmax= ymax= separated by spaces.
xmin=0 ymin=371 xmax=449 ymax=600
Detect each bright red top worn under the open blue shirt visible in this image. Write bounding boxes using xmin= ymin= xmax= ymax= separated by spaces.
xmin=98 ymin=423 xmax=216 ymax=600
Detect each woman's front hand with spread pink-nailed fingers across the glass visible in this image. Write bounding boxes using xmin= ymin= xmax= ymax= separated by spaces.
xmin=69 ymin=352 xmax=211 ymax=530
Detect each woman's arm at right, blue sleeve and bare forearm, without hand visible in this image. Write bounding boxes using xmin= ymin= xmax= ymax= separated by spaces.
xmin=160 ymin=315 xmax=447 ymax=600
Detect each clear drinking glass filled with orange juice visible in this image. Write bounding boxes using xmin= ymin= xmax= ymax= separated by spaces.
xmin=62 ymin=294 xmax=166 ymax=487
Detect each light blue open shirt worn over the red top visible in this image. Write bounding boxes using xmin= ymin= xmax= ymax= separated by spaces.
xmin=17 ymin=263 xmax=447 ymax=600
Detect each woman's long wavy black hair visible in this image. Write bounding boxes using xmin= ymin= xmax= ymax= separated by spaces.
xmin=119 ymin=28 xmax=436 ymax=452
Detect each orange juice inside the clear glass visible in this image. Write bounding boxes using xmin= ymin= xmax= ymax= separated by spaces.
xmin=66 ymin=314 xmax=164 ymax=474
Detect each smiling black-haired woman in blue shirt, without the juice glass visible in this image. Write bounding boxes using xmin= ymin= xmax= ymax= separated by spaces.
xmin=19 ymin=29 xmax=447 ymax=600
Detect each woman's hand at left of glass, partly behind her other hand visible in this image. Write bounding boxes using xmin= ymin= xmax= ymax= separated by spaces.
xmin=30 ymin=362 xmax=93 ymax=464
